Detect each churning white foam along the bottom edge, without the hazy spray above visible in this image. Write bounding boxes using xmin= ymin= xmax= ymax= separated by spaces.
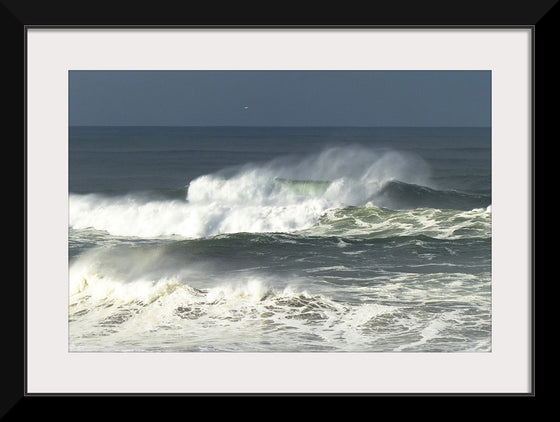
xmin=69 ymin=268 xmax=488 ymax=352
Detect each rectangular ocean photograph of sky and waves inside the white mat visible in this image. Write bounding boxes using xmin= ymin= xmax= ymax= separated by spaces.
xmin=68 ymin=70 xmax=492 ymax=353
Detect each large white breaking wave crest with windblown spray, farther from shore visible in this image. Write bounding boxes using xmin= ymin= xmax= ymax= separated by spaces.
xmin=69 ymin=148 xmax=428 ymax=238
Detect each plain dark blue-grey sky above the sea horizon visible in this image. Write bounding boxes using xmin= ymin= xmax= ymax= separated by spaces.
xmin=69 ymin=71 xmax=491 ymax=126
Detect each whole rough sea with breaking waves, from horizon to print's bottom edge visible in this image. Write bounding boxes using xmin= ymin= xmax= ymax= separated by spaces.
xmin=68 ymin=127 xmax=492 ymax=353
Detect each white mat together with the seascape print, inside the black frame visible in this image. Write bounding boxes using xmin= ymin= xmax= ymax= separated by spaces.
xmin=12 ymin=0 xmax=548 ymax=409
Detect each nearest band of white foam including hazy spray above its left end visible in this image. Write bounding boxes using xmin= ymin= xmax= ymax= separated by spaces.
xmin=69 ymin=241 xmax=490 ymax=351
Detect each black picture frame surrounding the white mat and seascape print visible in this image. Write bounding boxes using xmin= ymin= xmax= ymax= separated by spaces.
xmin=9 ymin=0 xmax=558 ymax=420
